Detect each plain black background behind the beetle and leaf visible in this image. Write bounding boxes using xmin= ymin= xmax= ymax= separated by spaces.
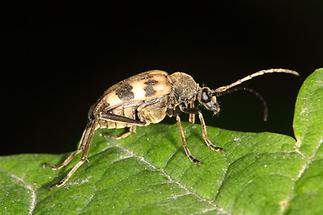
xmin=0 ymin=0 xmax=323 ymax=154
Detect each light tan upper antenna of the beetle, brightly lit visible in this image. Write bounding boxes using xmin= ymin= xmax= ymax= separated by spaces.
xmin=214 ymin=68 xmax=299 ymax=93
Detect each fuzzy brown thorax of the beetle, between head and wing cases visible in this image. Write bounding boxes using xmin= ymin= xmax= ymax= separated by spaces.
xmin=169 ymin=72 xmax=199 ymax=103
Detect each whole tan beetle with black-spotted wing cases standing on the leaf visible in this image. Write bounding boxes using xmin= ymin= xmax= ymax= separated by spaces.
xmin=48 ymin=68 xmax=299 ymax=187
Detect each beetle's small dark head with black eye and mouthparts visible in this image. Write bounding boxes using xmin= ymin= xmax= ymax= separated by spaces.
xmin=197 ymin=87 xmax=220 ymax=114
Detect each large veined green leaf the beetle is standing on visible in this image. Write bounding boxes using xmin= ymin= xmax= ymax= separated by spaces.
xmin=0 ymin=69 xmax=323 ymax=214
